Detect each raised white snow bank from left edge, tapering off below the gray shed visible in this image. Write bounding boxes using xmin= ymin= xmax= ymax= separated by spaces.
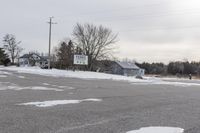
xmin=0 ymin=67 xmax=142 ymax=82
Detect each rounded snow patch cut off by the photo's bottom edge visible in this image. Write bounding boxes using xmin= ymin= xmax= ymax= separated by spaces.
xmin=126 ymin=127 xmax=184 ymax=133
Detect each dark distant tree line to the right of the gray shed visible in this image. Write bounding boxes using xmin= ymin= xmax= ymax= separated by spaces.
xmin=137 ymin=61 xmax=200 ymax=76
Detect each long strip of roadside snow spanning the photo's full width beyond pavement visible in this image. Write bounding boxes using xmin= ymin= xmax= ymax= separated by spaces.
xmin=0 ymin=66 xmax=200 ymax=89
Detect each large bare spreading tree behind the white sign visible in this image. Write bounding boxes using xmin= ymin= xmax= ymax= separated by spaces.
xmin=73 ymin=23 xmax=117 ymax=70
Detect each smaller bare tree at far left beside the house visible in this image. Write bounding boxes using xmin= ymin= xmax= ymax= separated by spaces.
xmin=3 ymin=34 xmax=23 ymax=63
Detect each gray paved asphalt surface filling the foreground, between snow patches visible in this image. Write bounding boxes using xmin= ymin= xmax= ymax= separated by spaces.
xmin=0 ymin=72 xmax=200 ymax=133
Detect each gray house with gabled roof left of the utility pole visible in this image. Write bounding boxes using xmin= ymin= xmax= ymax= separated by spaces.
xmin=19 ymin=53 xmax=48 ymax=68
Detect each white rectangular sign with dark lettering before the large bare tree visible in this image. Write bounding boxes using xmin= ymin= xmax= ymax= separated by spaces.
xmin=74 ymin=55 xmax=88 ymax=65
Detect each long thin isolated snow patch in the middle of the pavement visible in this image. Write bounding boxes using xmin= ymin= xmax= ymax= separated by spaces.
xmin=18 ymin=98 xmax=102 ymax=107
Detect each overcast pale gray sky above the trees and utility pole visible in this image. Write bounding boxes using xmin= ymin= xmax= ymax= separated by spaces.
xmin=0 ymin=0 xmax=200 ymax=63
